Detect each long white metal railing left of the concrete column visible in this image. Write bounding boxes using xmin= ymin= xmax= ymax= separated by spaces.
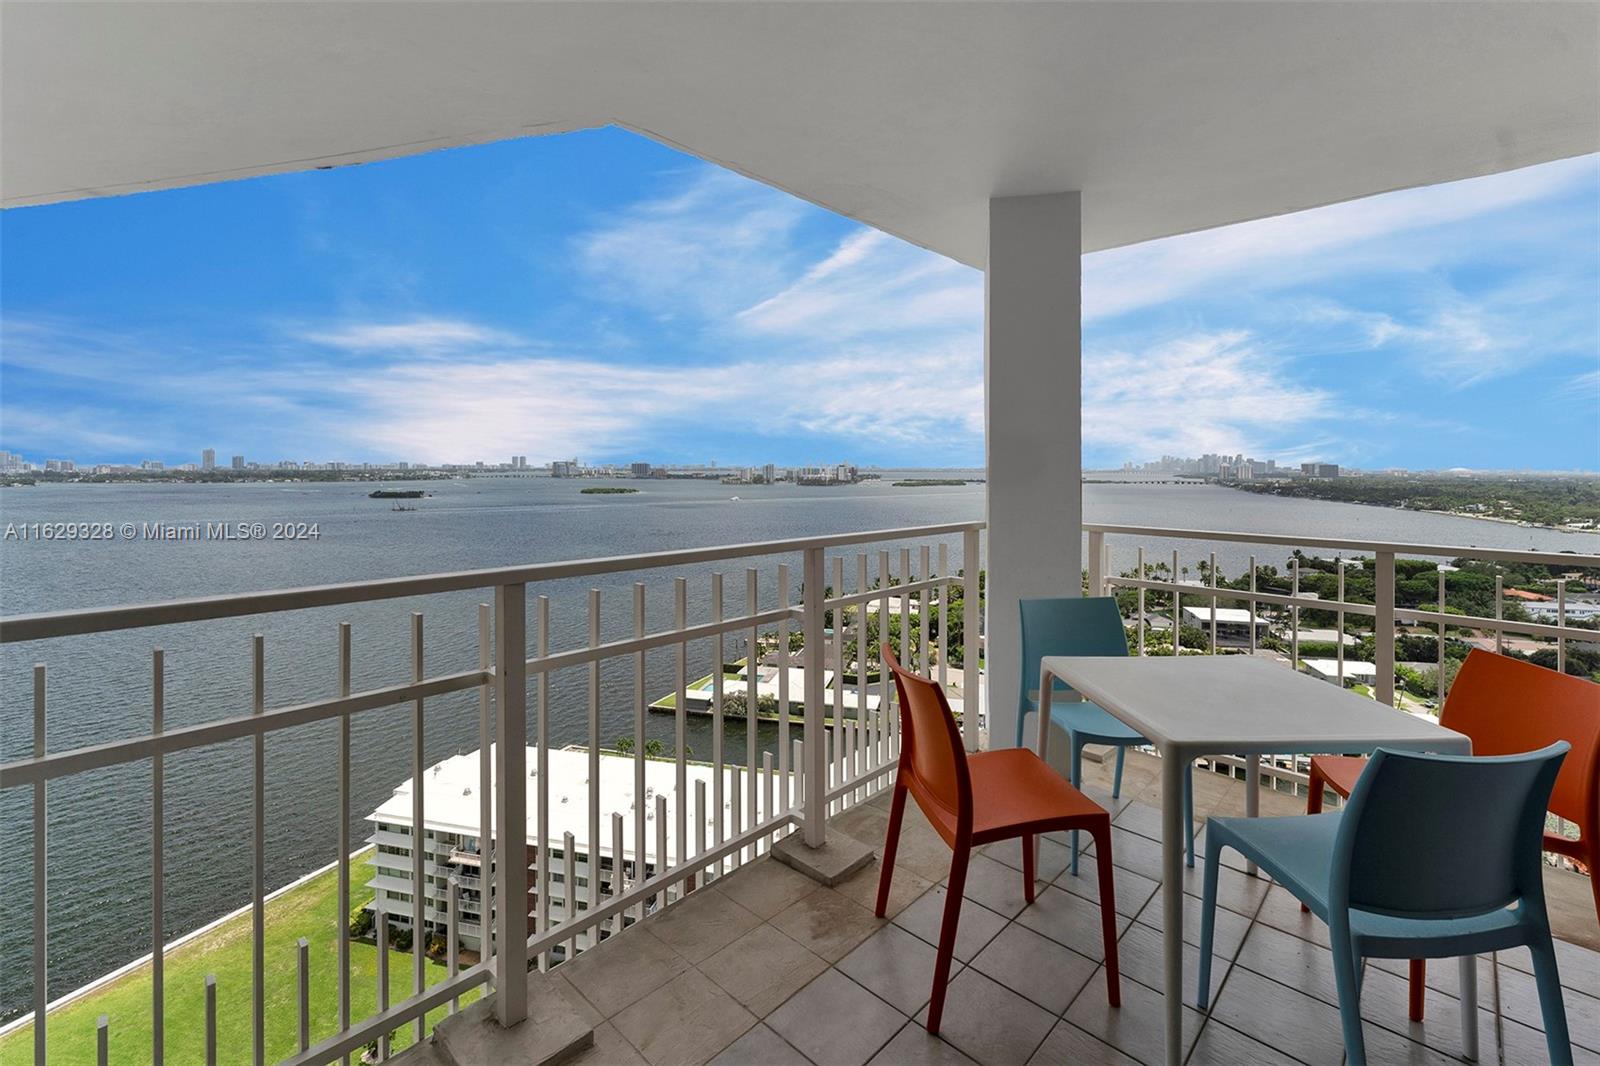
xmin=0 ymin=522 xmax=982 ymax=1064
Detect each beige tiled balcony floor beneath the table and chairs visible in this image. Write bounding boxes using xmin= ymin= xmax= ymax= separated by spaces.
xmin=402 ymin=754 xmax=1600 ymax=1066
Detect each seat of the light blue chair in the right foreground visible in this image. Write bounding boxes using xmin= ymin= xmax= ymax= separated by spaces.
xmin=1206 ymin=812 xmax=1525 ymax=959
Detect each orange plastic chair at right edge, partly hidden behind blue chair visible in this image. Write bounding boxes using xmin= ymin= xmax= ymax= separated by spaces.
xmin=1306 ymin=648 xmax=1600 ymax=1021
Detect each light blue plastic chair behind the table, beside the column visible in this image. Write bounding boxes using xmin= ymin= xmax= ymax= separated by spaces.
xmin=1016 ymin=595 xmax=1195 ymax=877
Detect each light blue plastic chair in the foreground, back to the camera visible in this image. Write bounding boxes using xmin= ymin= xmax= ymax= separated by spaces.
xmin=1198 ymin=741 xmax=1573 ymax=1066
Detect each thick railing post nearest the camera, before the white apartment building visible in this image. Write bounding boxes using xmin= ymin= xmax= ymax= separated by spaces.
xmin=483 ymin=584 xmax=531 ymax=1028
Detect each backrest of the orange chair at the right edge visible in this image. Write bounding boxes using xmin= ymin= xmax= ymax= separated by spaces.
xmin=1438 ymin=648 xmax=1600 ymax=836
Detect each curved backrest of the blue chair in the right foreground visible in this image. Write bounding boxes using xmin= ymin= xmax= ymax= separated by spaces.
xmin=1330 ymin=741 xmax=1570 ymax=917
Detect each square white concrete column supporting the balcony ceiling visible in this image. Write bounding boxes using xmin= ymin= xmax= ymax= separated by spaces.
xmin=984 ymin=192 xmax=1083 ymax=751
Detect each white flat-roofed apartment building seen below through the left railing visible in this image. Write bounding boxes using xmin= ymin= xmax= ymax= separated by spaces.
xmin=366 ymin=747 xmax=749 ymax=954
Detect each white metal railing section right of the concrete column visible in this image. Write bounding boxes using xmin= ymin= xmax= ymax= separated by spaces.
xmin=1083 ymin=525 xmax=1600 ymax=791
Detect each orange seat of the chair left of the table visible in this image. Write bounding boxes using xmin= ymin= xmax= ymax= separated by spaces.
xmin=966 ymin=742 xmax=1110 ymax=844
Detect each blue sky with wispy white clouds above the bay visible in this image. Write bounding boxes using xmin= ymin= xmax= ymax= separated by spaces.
xmin=0 ymin=130 xmax=1600 ymax=471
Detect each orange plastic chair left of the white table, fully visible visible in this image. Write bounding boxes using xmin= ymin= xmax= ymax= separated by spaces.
xmin=877 ymin=648 xmax=1122 ymax=1032
